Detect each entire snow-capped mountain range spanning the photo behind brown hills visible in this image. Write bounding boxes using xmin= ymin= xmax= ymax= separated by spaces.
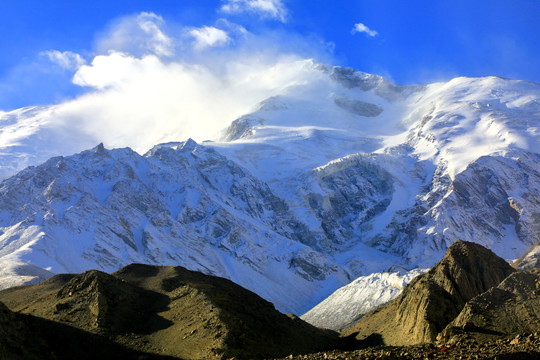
xmin=0 ymin=61 xmax=540 ymax=314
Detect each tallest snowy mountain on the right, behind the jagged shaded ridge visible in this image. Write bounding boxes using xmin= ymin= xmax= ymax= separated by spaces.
xmin=210 ymin=67 xmax=540 ymax=268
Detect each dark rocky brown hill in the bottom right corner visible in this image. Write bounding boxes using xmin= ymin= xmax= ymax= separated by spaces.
xmin=439 ymin=269 xmax=540 ymax=342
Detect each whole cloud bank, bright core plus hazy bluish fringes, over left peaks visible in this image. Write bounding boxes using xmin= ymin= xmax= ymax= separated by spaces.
xmin=0 ymin=13 xmax=331 ymax=175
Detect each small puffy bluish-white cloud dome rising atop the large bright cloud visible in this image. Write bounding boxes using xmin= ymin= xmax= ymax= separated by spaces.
xmin=96 ymin=12 xmax=174 ymax=56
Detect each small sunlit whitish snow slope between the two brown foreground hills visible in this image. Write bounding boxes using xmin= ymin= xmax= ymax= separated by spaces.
xmin=301 ymin=269 xmax=428 ymax=331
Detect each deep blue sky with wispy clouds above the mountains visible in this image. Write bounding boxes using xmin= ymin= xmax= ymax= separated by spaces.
xmin=0 ymin=0 xmax=540 ymax=110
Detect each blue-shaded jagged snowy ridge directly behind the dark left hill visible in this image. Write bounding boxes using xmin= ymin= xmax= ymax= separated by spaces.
xmin=0 ymin=140 xmax=349 ymax=312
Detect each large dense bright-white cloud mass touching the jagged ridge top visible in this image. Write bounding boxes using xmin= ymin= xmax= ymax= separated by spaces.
xmin=54 ymin=53 xmax=318 ymax=152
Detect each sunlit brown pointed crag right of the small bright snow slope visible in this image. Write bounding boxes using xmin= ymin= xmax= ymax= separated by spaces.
xmin=344 ymin=241 xmax=514 ymax=345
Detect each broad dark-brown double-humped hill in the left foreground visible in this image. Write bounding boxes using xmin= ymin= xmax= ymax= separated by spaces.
xmin=0 ymin=264 xmax=337 ymax=359
